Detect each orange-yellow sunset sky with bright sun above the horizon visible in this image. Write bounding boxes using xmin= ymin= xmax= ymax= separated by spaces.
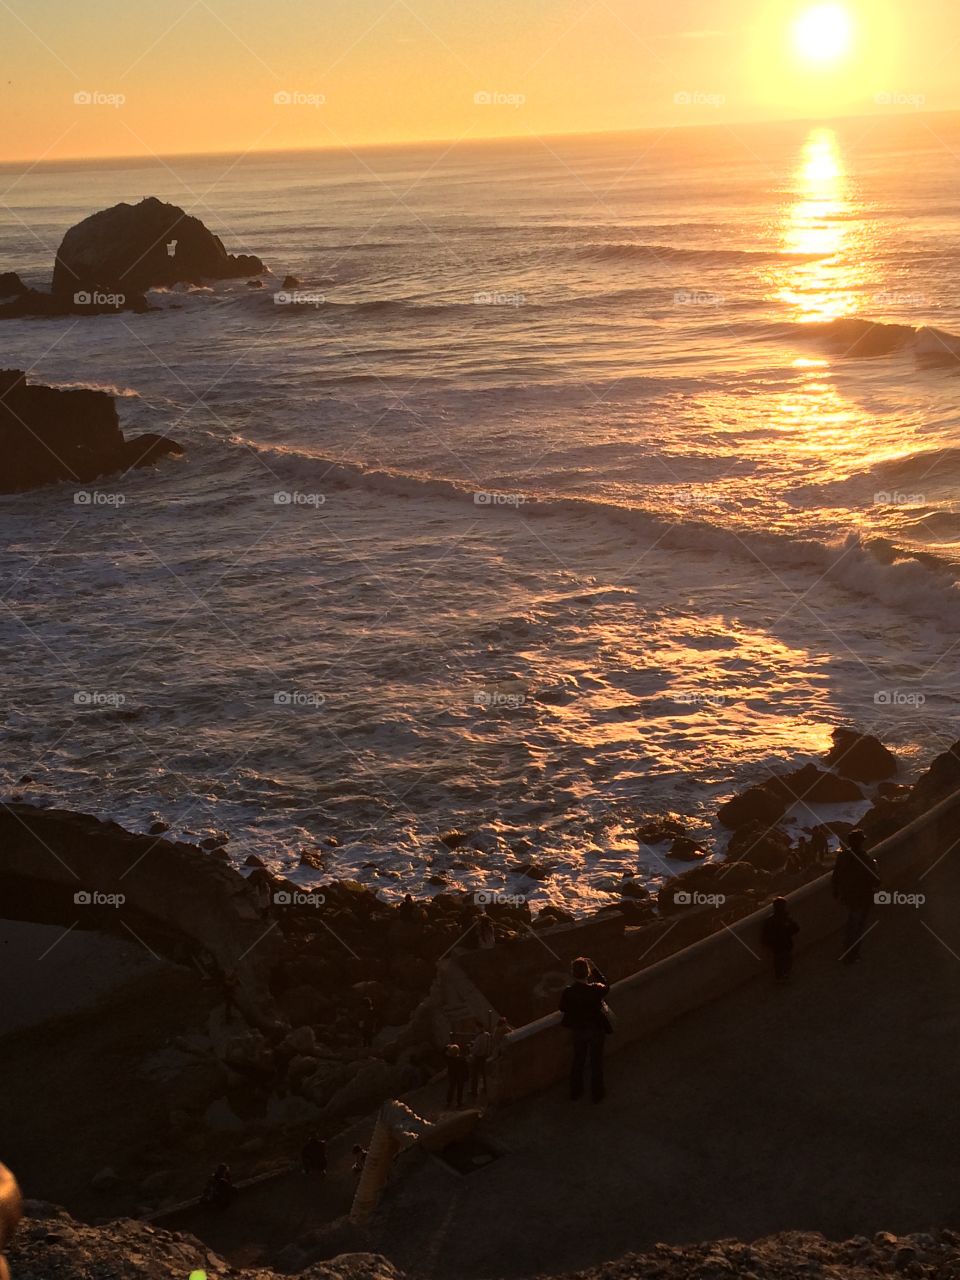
xmin=0 ymin=0 xmax=960 ymax=160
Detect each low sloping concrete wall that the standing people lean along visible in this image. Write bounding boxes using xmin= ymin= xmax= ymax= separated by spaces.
xmin=499 ymin=792 xmax=960 ymax=1101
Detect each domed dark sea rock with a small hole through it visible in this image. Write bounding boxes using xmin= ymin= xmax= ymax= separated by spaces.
xmin=52 ymin=196 xmax=265 ymax=298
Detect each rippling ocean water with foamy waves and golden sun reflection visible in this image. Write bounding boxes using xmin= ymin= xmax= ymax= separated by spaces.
xmin=0 ymin=115 xmax=960 ymax=910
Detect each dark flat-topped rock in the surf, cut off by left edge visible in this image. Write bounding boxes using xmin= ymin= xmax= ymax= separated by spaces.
xmin=0 ymin=369 xmax=183 ymax=503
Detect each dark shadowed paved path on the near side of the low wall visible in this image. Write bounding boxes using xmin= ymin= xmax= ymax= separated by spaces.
xmin=181 ymin=844 xmax=960 ymax=1280
